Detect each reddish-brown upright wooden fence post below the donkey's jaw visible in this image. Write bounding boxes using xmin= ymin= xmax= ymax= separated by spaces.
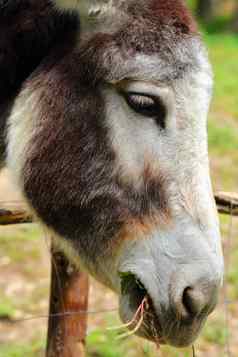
xmin=46 ymin=249 xmax=89 ymax=357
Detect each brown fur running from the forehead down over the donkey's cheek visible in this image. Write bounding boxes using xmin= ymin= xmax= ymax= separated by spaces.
xmin=17 ymin=2 xmax=197 ymax=259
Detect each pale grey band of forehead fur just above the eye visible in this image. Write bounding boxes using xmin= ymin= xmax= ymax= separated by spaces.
xmin=103 ymin=38 xmax=211 ymax=84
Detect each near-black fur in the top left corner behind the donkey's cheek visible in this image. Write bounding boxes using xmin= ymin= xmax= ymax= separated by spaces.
xmin=0 ymin=0 xmax=77 ymax=100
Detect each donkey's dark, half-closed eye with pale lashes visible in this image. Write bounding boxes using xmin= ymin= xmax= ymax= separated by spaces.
xmin=124 ymin=92 xmax=166 ymax=128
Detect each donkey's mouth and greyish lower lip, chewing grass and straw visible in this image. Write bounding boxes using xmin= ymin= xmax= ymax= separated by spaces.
xmin=117 ymin=273 xmax=205 ymax=347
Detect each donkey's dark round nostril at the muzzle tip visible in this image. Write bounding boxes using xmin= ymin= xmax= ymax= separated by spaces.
xmin=182 ymin=287 xmax=206 ymax=317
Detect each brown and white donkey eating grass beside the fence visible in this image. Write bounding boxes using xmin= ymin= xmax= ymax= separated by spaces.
xmin=0 ymin=0 xmax=223 ymax=347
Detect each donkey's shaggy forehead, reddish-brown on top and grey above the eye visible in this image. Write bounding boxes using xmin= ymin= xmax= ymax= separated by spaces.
xmin=76 ymin=0 xmax=201 ymax=80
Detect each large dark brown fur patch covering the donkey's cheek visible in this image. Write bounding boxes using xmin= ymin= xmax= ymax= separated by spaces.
xmin=24 ymin=50 xmax=167 ymax=256
